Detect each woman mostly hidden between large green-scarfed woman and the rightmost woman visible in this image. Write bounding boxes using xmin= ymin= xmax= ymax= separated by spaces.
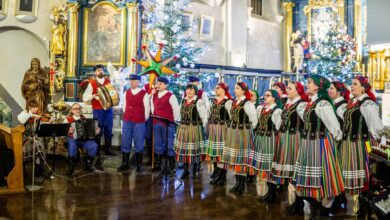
xmin=328 ymin=81 xmax=350 ymax=213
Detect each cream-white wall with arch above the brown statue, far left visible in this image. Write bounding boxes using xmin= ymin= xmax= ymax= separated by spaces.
xmin=0 ymin=0 xmax=65 ymax=108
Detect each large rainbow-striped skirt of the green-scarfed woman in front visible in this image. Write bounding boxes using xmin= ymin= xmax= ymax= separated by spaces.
xmin=294 ymin=132 xmax=344 ymax=199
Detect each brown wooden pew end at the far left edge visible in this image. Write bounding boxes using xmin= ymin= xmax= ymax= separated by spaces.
xmin=0 ymin=124 xmax=25 ymax=194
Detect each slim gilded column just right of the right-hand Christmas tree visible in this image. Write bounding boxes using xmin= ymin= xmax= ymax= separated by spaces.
xmin=354 ymin=0 xmax=363 ymax=71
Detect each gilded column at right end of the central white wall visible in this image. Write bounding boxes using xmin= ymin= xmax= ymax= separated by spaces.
xmin=283 ymin=2 xmax=294 ymax=72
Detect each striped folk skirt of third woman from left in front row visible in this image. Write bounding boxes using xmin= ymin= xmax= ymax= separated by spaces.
xmin=221 ymin=128 xmax=254 ymax=173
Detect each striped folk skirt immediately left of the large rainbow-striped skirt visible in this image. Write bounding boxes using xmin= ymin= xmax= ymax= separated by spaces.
xmin=272 ymin=131 xmax=301 ymax=184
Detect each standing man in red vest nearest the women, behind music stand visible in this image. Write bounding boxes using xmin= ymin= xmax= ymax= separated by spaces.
xmin=151 ymin=77 xmax=180 ymax=172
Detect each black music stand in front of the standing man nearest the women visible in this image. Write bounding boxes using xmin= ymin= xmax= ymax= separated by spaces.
xmin=150 ymin=115 xmax=183 ymax=186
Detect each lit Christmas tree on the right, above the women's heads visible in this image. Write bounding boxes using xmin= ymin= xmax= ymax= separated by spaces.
xmin=304 ymin=8 xmax=356 ymax=82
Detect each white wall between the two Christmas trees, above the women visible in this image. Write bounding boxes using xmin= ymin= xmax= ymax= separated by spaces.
xmin=187 ymin=0 xmax=283 ymax=70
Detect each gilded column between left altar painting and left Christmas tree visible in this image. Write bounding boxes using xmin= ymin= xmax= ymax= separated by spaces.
xmin=127 ymin=3 xmax=138 ymax=73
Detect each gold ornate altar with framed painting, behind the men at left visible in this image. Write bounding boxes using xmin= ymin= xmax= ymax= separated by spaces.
xmin=50 ymin=0 xmax=140 ymax=101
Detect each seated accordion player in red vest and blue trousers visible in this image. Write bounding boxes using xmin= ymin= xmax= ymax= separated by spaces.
xmin=64 ymin=103 xmax=100 ymax=176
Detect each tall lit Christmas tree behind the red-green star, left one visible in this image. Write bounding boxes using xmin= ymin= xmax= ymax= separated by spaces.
xmin=142 ymin=0 xmax=207 ymax=96
